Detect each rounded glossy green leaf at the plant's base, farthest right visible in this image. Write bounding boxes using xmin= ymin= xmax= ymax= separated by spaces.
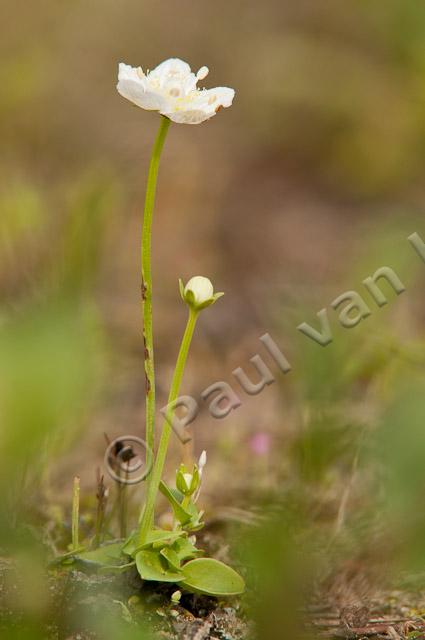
xmin=181 ymin=558 xmax=245 ymax=596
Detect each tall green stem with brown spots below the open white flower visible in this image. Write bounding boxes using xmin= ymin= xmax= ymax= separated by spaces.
xmin=141 ymin=116 xmax=171 ymax=510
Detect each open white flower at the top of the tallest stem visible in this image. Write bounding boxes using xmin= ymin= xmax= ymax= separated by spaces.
xmin=117 ymin=58 xmax=235 ymax=124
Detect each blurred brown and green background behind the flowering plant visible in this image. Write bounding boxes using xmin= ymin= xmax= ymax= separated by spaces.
xmin=0 ymin=0 xmax=425 ymax=638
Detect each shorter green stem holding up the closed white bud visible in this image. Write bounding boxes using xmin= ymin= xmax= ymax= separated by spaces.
xmin=139 ymin=308 xmax=199 ymax=544
